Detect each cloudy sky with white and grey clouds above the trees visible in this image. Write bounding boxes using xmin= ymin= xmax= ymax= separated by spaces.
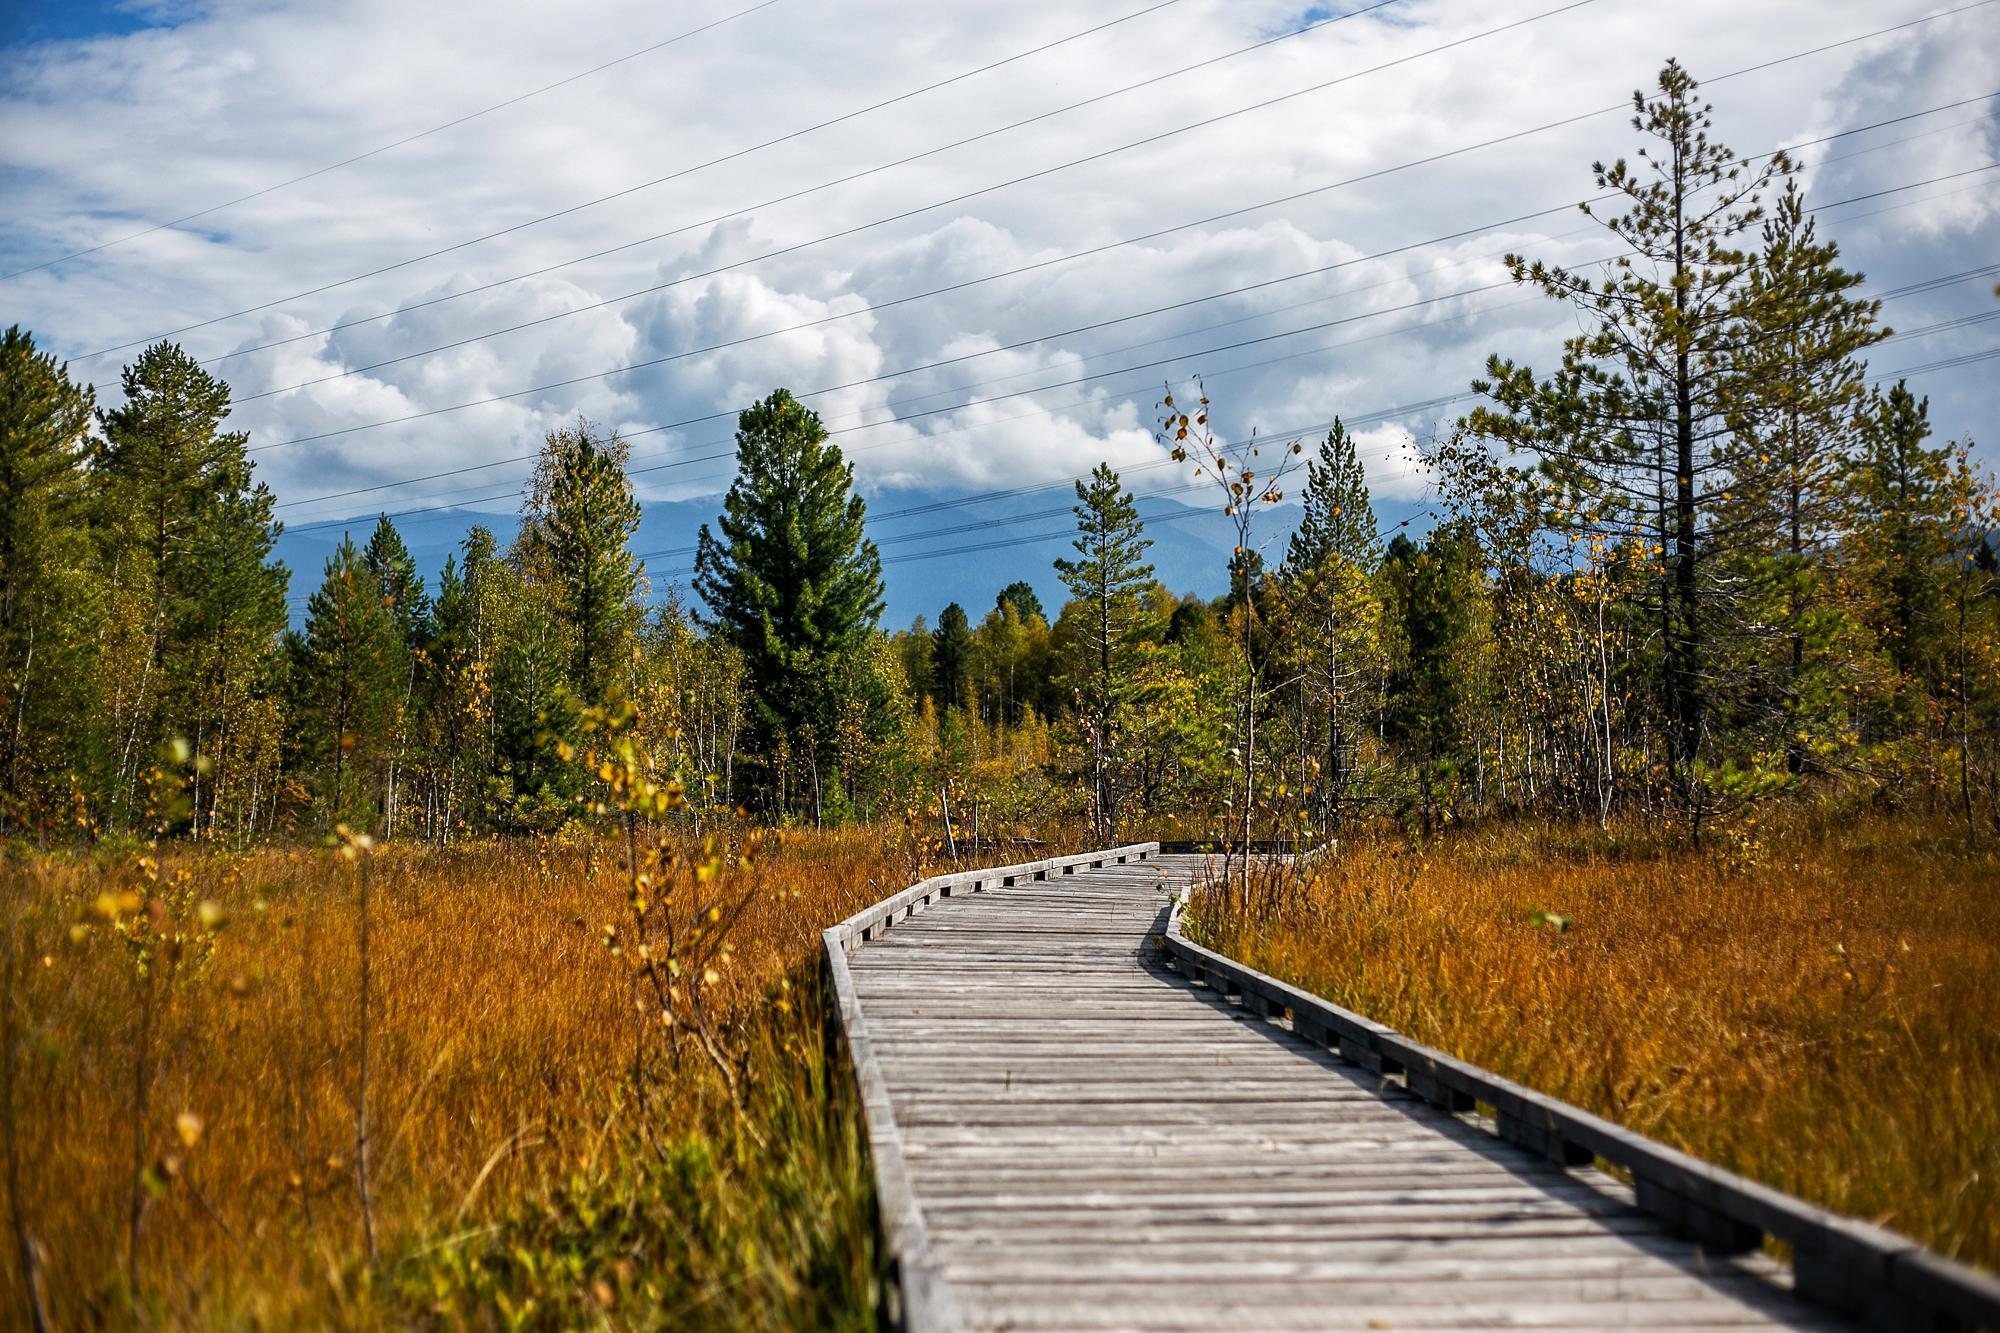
xmin=0 ymin=0 xmax=2000 ymax=608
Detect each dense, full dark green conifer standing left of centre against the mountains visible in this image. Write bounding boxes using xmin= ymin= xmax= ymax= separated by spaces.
xmin=694 ymin=388 xmax=882 ymax=815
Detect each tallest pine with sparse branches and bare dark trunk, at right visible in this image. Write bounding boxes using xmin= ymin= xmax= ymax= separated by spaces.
xmin=1468 ymin=60 xmax=1790 ymax=835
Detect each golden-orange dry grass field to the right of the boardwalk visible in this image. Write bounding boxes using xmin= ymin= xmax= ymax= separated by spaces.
xmin=1196 ymin=813 xmax=2000 ymax=1267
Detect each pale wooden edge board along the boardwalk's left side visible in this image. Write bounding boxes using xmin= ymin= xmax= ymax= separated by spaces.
xmin=820 ymin=843 xmax=1160 ymax=1333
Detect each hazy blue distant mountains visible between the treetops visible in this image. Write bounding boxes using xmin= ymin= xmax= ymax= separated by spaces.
xmin=278 ymin=484 xmax=1428 ymax=628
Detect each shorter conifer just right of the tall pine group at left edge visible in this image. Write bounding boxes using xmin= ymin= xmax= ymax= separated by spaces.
xmin=288 ymin=536 xmax=402 ymax=827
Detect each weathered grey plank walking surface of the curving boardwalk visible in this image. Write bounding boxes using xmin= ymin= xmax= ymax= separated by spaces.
xmin=850 ymin=857 xmax=1846 ymax=1329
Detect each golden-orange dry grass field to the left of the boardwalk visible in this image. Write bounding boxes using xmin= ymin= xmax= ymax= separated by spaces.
xmin=0 ymin=831 xmax=1000 ymax=1327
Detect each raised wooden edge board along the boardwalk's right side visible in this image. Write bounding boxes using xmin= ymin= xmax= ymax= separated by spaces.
xmin=1160 ymin=876 xmax=2000 ymax=1333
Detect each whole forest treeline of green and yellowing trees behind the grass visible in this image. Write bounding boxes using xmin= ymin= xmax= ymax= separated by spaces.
xmin=0 ymin=64 xmax=2000 ymax=845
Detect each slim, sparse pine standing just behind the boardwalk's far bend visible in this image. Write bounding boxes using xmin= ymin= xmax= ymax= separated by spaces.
xmin=1056 ymin=462 xmax=1152 ymax=843
